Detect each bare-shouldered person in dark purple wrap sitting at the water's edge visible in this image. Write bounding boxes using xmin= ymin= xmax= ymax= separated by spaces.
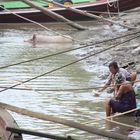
xmin=105 ymin=73 xmax=136 ymax=116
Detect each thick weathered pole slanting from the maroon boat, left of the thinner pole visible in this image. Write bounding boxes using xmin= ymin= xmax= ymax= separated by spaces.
xmin=22 ymin=0 xmax=87 ymax=30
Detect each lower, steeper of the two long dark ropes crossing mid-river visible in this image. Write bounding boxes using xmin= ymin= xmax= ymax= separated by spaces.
xmin=0 ymin=35 xmax=140 ymax=92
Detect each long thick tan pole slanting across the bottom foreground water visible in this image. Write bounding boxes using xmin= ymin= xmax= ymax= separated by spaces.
xmin=0 ymin=103 xmax=133 ymax=140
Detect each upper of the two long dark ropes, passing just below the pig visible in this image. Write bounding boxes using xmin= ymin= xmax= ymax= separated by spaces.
xmin=0 ymin=31 xmax=140 ymax=69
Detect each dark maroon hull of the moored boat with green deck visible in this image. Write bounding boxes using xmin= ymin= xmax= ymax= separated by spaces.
xmin=0 ymin=0 xmax=140 ymax=23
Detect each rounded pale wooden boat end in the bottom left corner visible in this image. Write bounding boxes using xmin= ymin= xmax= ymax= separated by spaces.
xmin=0 ymin=108 xmax=22 ymax=140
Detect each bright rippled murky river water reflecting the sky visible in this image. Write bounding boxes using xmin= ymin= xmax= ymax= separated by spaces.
xmin=0 ymin=23 xmax=139 ymax=140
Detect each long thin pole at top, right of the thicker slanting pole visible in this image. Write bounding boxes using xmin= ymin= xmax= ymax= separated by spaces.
xmin=44 ymin=0 xmax=136 ymax=29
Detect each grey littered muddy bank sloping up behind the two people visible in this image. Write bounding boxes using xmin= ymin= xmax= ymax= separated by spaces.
xmin=82 ymin=8 xmax=140 ymax=73
